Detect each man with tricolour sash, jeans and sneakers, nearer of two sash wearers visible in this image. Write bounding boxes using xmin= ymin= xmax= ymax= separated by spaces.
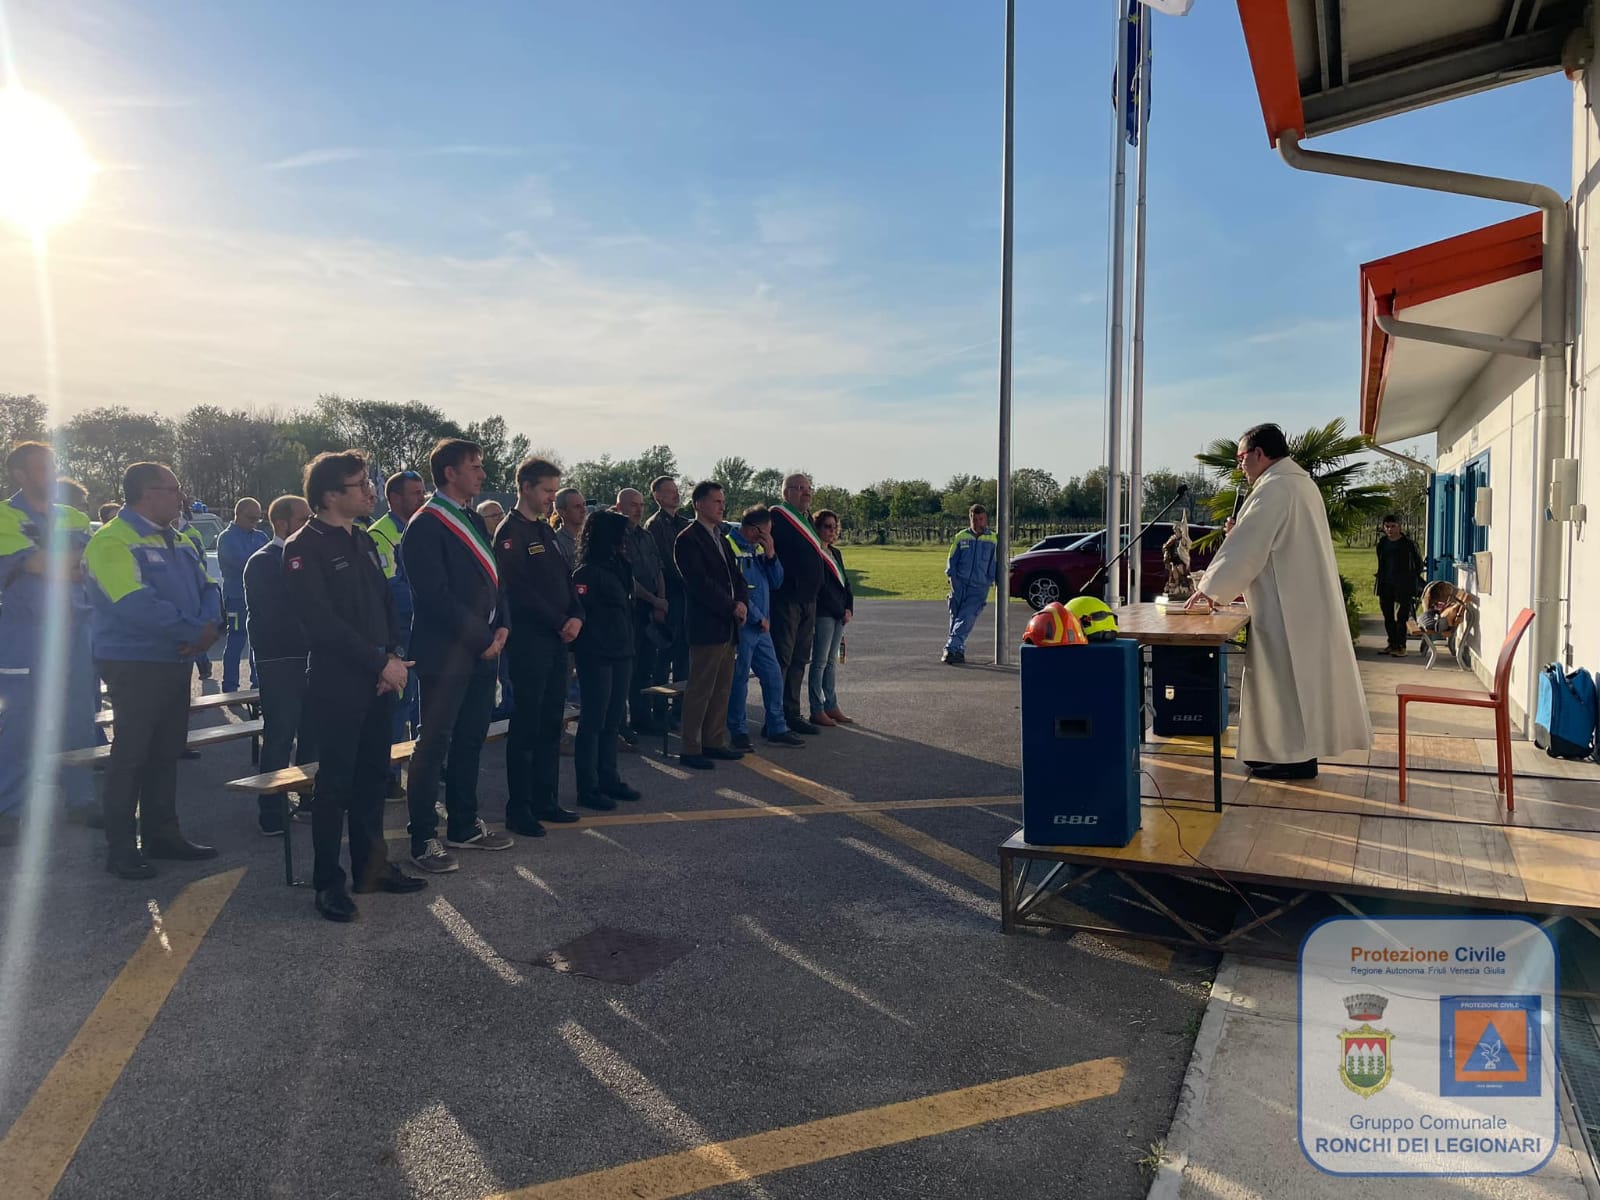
xmin=400 ymin=437 xmax=514 ymax=874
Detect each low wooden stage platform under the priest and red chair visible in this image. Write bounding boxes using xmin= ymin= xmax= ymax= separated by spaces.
xmin=1000 ymin=734 xmax=1600 ymax=950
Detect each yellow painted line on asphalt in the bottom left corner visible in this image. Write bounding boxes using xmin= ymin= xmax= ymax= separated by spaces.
xmin=0 ymin=867 xmax=245 ymax=1200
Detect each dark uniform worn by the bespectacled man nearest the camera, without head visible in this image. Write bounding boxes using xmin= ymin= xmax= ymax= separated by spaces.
xmin=283 ymin=518 xmax=400 ymax=891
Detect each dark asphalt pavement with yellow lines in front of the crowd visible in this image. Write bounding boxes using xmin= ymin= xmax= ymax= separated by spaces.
xmin=0 ymin=602 xmax=1214 ymax=1200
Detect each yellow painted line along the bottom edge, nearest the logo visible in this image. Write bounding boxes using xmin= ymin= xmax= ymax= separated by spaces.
xmin=491 ymin=1058 xmax=1125 ymax=1200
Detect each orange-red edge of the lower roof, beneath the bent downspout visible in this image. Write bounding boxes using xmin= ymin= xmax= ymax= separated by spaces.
xmin=1356 ymin=216 xmax=1544 ymax=437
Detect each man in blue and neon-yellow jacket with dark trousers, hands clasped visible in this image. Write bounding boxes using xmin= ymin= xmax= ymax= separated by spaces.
xmin=83 ymin=462 xmax=222 ymax=878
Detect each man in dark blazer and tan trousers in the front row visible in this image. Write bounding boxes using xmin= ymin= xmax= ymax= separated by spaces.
xmin=672 ymin=480 xmax=747 ymax=771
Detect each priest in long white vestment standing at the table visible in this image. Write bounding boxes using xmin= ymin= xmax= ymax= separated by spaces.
xmin=1187 ymin=426 xmax=1373 ymax=779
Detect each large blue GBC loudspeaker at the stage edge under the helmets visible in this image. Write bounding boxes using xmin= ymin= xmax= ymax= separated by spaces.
xmin=1022 ymin=638 xmax=1139 ymax=846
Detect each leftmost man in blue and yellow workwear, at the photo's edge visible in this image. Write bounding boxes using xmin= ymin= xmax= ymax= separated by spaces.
xmin=0 ymin=442 xmax=99 ymax=846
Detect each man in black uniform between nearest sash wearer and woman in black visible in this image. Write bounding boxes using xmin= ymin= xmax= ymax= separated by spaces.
xmin=494 ymin=459 xmax=584 ymax=837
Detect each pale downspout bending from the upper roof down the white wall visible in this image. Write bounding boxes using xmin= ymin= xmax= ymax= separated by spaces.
xmin=1278 ymin=131 xmax=1571 ymax=720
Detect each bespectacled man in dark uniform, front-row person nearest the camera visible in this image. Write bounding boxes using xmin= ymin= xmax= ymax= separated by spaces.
xmin=283 ymin=450 xmax=427 ymax=922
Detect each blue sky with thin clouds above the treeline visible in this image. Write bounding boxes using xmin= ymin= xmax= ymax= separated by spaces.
xmin=0 ymin=0 xmax=1571 ymax=486
